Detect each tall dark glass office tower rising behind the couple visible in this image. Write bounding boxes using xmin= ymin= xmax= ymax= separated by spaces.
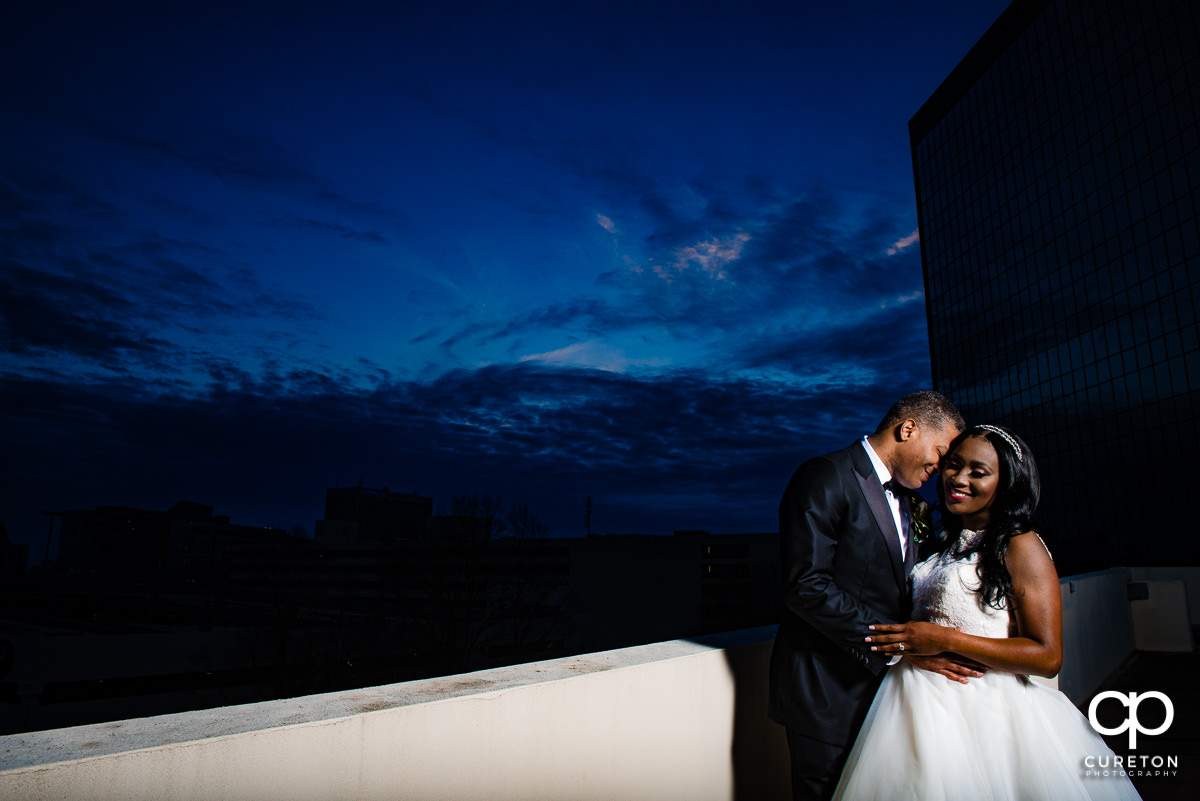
xmin=910 ymin=0 xmax=1200 ymax=573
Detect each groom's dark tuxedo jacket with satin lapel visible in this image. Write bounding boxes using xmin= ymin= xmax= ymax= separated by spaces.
xmin=768 ymin=442 xmax=914 ymax=745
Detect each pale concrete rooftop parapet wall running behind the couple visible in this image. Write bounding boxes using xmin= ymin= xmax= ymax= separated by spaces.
xmin=0 ymin=567 xmax=1200 ymax=801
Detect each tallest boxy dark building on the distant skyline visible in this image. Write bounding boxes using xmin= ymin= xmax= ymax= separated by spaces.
xmin=314 ymin=487 xmax=433 ymax=544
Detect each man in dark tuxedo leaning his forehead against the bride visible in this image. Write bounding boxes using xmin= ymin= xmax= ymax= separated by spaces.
xmin=768 ymin=392 xmax=982 ymax=801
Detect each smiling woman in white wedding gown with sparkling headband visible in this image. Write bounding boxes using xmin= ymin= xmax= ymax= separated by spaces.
xmin=834 ymin=426 xmax=1139 ymax=801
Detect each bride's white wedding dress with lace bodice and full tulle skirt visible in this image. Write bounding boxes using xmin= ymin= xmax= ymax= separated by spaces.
xmin=834 ymin=531 xmax=1140 ymax=801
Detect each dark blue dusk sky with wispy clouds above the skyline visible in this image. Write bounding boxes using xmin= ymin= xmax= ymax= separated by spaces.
xmin=0 ymin=0 xmax=1007 ymax=547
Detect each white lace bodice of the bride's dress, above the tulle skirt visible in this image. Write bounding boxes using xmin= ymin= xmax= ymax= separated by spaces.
xmin=912 ymin=530 xmax=1013 ymax=637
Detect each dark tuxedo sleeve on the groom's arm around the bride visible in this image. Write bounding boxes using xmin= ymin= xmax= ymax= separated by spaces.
xmin=779 ymin=458 xmax=892 ymax=674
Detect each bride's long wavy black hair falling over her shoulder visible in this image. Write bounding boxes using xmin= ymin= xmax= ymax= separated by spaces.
xmin=937 ymin=426 xmax=1042 ymax=609
